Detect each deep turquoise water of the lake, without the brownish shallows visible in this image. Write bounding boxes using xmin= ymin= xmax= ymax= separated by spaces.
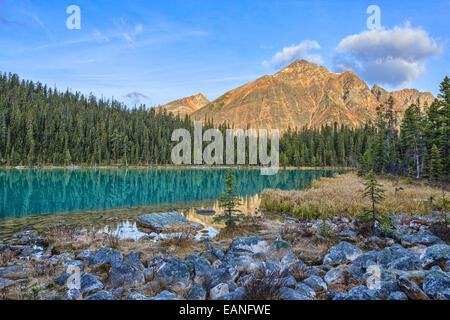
xmin=0 ymin=169 xmax=342 ymax=218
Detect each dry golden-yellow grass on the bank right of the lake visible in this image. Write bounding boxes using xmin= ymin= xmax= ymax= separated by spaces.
xmin=261 ymin=173 xmax=443 ymax=220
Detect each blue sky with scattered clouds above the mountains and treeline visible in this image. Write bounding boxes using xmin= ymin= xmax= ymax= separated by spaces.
xmin=0 ymin=0 xmax=450 ymax=106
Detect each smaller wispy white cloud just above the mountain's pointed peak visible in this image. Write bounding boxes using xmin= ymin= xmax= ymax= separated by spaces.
xmin=263 ymin=40 xmax=323 ymax=67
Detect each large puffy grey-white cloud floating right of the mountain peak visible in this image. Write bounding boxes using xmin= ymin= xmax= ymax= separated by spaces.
xmin=333 ymin=23 xmax=442 ymax=86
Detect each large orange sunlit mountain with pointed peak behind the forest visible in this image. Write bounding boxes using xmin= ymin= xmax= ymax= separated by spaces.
xmin=191 ymin=60 xmax=434 ymax=132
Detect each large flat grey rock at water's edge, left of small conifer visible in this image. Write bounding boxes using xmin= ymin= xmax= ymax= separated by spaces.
xmin=137 ymin=211 xmax=204 ymax=232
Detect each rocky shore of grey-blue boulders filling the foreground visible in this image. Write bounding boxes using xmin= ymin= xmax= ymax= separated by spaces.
xmin=0 ymin=213 xmax=450 ymax=300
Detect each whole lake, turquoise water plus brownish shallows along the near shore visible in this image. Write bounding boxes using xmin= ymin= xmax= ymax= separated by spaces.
xmin=0 ymin=169 xmax=337 ymax=239
